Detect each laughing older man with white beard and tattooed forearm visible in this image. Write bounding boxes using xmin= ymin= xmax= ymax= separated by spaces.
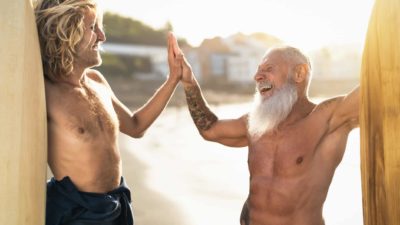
xmin=182 ymin=44 xmax=359 ymax=225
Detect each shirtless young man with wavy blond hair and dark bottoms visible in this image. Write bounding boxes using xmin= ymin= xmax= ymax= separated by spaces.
xmin=35 ymin=0 xmax=182 ymax=225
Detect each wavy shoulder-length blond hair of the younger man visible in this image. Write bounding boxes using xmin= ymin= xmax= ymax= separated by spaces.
xmin=34 ymin=0 xmax=96 ymax=81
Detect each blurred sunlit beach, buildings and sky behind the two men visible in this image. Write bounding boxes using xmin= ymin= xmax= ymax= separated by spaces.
xmin=91 ymin=0 xmax=373 ymax=225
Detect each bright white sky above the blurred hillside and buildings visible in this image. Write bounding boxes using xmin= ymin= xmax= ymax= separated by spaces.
xmin=98 ymin=0 xmax=374 ymax=50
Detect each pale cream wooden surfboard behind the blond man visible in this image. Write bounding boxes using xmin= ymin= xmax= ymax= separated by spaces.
xmin=0 ymin=0 xmax=47 ymax=225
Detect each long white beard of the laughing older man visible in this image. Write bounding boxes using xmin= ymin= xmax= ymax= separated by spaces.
xmin=248 ymin=81 xmax=298 ymax=138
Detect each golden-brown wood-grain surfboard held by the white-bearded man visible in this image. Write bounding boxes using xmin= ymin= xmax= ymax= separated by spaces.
xmin=360 ymin=0 xmax=400 ymax=225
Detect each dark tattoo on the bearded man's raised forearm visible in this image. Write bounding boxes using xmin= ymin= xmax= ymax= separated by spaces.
xmin=185 ymin=85 xmax=218 ymax=130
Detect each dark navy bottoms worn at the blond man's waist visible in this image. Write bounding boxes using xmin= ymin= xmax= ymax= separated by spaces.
xmin=46 ymin=177 xmax=134 ymax=225
